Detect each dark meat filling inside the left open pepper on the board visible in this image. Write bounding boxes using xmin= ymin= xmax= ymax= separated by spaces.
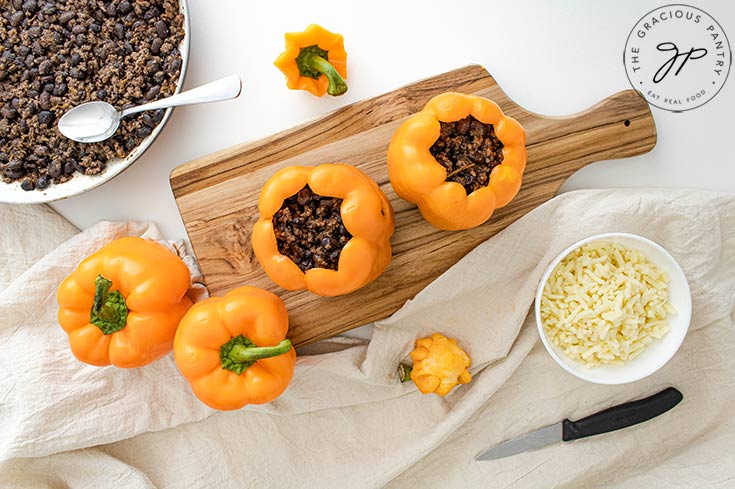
xmin=273 ymin=185 xmax=352 ymax=272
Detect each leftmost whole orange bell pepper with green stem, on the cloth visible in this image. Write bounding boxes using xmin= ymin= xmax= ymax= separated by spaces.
xmin=56 ymin=237 xmax=191 ymax=368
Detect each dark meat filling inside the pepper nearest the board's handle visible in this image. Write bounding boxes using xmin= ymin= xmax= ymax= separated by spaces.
xmin=430 ymin=115 xmax=503 ymax=195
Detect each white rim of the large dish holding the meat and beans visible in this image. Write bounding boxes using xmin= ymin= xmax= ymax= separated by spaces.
xmin=0 ymin=0 xmax=191 ymax=204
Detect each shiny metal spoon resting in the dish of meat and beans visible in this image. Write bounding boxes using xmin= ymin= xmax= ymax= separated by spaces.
xmin=58 ymin=75 xmax=242 ymax=143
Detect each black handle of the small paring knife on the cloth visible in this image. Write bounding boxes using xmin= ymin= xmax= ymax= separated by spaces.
xmin=561 ymin=387 xmax=683 ymax=441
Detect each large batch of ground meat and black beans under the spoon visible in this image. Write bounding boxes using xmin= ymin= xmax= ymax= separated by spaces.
xmin=0 ymin=0 xmax=184 ymax=190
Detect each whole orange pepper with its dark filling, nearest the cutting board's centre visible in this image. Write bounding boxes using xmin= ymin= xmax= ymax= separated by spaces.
xmin=252 ymin=164 xmax=394 ymax=296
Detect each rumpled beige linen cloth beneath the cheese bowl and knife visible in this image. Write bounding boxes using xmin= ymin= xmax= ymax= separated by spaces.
xmin=0 ymin=190 xmax=735 ymax=488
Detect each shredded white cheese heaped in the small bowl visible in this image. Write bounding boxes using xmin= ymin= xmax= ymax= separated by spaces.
xmin=540 ymin=241 xmax=676 ymax=367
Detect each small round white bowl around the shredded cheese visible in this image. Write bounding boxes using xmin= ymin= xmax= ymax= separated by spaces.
xmin=535 ymin=233 xmax=692 ymax=384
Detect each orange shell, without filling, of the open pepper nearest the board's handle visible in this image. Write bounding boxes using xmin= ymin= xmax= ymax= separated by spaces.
xmin=388 ymin=92 xmax=527 ymax=230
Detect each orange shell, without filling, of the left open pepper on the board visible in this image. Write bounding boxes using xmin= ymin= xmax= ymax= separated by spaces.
xmin=252 ymin=164 xmax=394 ymax=296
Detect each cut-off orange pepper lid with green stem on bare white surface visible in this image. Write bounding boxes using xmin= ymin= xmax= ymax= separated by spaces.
xmin=274 ymin=24 xmax=347 ymax=97
